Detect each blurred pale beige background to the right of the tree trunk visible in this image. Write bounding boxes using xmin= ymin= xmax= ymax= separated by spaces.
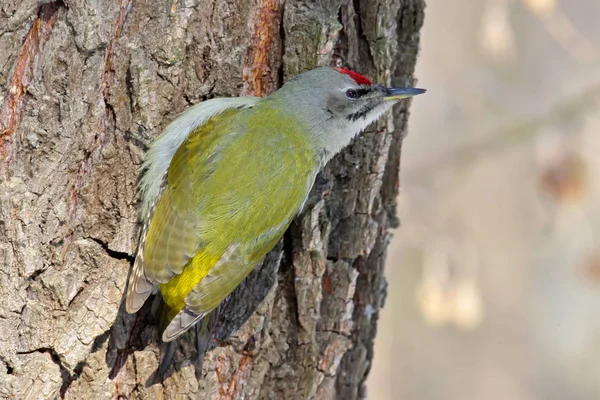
xmin=368 ymin=0 xmax=600 ymax=400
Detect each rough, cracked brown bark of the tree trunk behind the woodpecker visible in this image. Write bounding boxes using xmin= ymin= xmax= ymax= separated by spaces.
xmin=0 ymin=0 xmax=424 ymax=399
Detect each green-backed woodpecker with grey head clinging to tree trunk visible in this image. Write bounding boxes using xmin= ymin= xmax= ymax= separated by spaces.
xmin=126 ymin=68 xmax=424 ymax=342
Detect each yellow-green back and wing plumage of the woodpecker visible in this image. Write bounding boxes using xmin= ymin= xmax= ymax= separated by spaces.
xmin=143 ymin=102 xmax=317 ymax=334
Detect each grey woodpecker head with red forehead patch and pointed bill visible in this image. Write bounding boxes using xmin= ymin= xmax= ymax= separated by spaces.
xmin=266 ymin=67 xmax=425 ymax=164
